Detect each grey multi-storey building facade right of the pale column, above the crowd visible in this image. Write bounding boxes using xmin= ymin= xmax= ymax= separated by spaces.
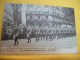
xmin=26 ymin=5 xmax=75 ymax=28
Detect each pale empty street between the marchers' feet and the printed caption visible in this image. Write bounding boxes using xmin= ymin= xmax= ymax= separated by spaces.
xmin=1 ymin=37 xmax=76 ymax=47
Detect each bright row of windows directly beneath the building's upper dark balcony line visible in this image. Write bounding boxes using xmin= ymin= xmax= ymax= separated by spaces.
xmin=26 ymin=15 xmax=73 ymax=24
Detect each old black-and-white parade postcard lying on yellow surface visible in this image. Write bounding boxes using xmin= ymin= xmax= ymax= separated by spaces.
xmin=0 ymin=3 xmax=77 ymax=54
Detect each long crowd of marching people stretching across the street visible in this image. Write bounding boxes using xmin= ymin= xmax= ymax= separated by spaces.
xmin=2 ymin=26 xmax=76 ymax=43
